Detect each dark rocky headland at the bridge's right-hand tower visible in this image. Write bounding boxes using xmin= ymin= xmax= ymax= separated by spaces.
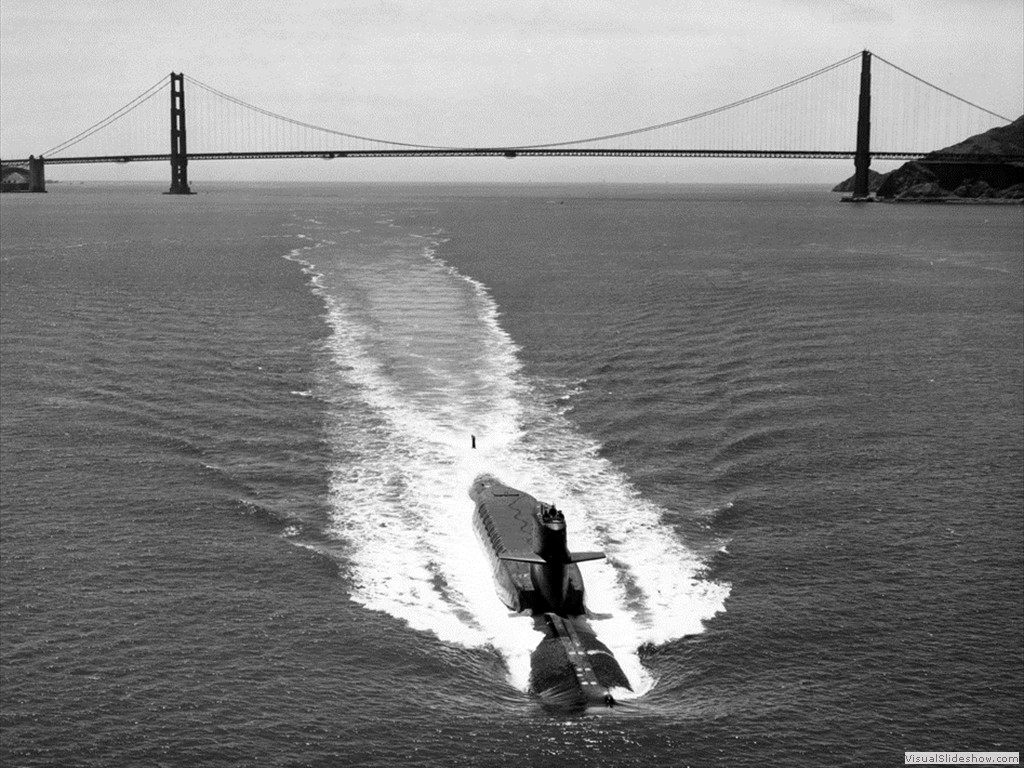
xmin=833 ymin=115 xmax=1024 ymax=204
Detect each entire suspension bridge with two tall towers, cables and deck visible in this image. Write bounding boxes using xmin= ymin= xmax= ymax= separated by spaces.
xmin=3 ymin=50 xmax=1024 ymax=200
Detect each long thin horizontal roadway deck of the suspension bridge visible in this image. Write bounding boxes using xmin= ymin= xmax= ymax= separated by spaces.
xmin=4 ymin=146 xmax=1024 ymax=165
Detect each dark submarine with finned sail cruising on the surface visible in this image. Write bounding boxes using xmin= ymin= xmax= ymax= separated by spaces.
xmin=469 ymin=475 xmax=632 ymax=709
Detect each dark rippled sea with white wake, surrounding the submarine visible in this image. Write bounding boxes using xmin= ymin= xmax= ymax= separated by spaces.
xmin=0 ymin=183 xmax=1024 ymax=768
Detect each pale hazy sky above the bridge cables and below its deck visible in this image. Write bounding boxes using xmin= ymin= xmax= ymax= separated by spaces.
xmin=0 ymin=0 xmax=1024 ymax=183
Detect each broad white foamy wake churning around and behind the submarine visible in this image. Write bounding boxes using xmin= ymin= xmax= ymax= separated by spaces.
xmin=289 ymin=227 xmax=728 ymax=693
